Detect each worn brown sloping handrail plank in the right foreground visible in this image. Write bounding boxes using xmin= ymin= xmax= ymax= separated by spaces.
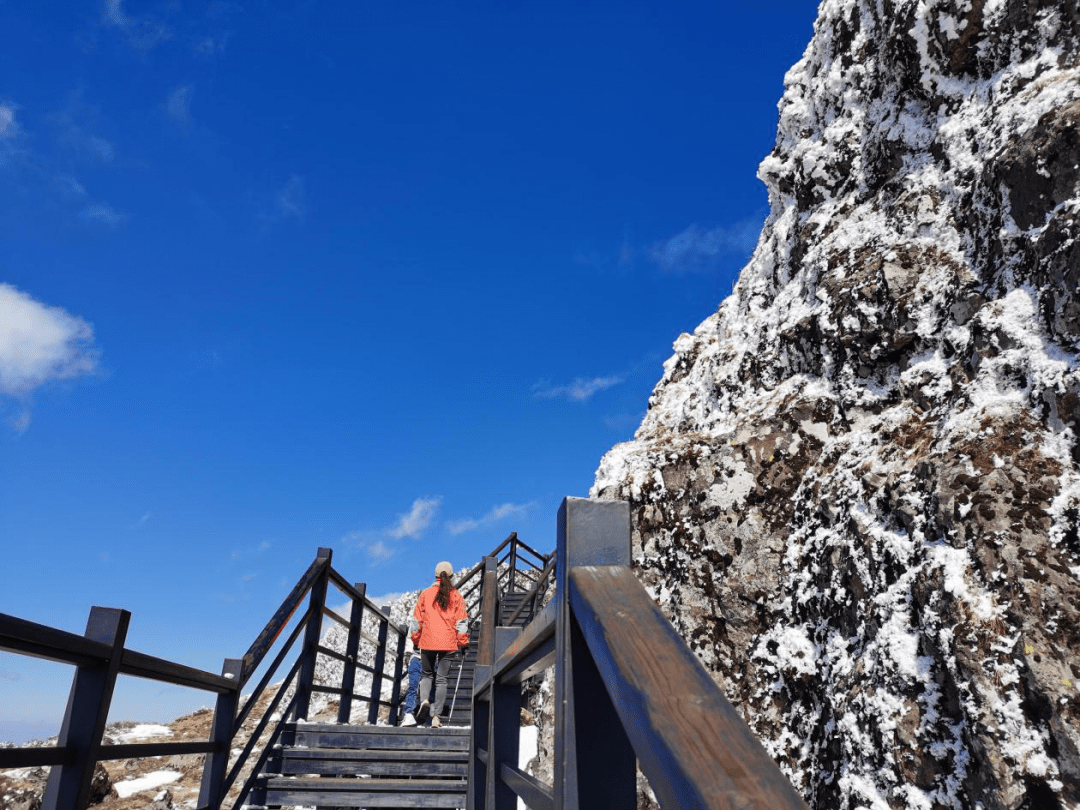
xmin=568 ymin=566 xmax=806 ymax=810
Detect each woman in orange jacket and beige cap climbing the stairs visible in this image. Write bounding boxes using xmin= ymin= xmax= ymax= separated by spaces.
xmin=413 ymin=563 xmax=469 ymax=728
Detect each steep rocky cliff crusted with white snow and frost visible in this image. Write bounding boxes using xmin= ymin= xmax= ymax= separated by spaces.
xmin=593 ymin=0 xmax=1080 ymax=810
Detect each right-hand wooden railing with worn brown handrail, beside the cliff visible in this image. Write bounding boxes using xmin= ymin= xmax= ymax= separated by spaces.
xmin=468 ymin=498 xmax=806 ymax=810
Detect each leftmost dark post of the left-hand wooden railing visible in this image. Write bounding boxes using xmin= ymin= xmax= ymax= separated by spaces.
xmin=41 ymin=607 xmax=132 ymax=810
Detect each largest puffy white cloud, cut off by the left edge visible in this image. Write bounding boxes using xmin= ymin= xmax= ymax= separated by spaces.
xmin=0 ymin=283 xmax=98 ymax=399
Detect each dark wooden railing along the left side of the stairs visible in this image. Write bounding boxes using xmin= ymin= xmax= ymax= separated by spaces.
xmin=0 ymin=549 xmax=406 ymax=810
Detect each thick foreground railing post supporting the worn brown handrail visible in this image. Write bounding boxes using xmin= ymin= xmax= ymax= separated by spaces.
xmin=553 ymin=498 xmax=637 ymax=810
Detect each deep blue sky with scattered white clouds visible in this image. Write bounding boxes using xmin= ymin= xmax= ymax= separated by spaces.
xmin=0 ymin=0 xmax=815 ymax=740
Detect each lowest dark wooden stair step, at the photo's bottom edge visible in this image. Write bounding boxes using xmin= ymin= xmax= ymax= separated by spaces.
xmin=266 ymin=777 xmax=467 ymax=808
